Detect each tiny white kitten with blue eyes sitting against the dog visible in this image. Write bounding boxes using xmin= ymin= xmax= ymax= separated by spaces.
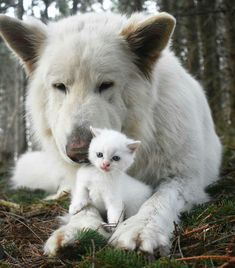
xmin=69 ymin=128 xmax=152 ymax=224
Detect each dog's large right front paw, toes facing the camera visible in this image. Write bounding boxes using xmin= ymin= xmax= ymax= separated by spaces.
xmin=109 ymin=215 xmax=170 ymax=256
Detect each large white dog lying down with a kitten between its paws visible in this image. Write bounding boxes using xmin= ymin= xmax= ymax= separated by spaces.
xmin=0 ymin=13 xmax=221 ymax=255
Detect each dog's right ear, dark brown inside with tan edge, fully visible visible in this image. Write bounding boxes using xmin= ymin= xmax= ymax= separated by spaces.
xmin=121 ymin=12 xmax=175 ymax=78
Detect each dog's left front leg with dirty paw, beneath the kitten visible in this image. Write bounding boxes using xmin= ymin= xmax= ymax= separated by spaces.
xmin=44 ymin=206 xmax=109 ymax=256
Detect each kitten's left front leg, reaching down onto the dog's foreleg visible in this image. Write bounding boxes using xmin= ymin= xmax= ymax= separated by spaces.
xmin=69 ymin=183 xmax=89 ymax=214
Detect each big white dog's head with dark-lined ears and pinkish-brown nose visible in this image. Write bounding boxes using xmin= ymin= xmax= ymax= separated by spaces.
xmin=0 ymin=13 xmax=175 ymax=162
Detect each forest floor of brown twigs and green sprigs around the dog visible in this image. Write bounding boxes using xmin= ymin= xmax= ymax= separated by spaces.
xmin=0 ymin=148 xmax=235 ymax=268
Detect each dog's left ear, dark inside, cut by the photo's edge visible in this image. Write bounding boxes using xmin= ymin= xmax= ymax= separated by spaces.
xmin=0 ymin=15 xmax=46 ymax=74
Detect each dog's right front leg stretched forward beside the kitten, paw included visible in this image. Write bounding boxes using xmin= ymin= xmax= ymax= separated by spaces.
xmin=110 ymin=178 xmax=207 ymax=255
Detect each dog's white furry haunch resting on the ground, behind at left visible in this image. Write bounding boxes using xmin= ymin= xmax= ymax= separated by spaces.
xmin=11 ymin=151 xmax=75 ymax=200
